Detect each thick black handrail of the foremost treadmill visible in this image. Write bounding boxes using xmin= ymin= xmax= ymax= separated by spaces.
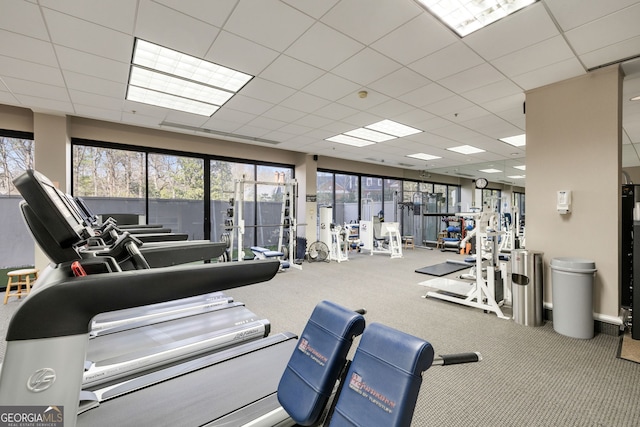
xmin=6 ymin=260 xmax=280 ymax=341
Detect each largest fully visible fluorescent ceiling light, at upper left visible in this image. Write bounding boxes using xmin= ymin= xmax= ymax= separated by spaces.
xmin=127 ymin=39 xmax=253 ymax=116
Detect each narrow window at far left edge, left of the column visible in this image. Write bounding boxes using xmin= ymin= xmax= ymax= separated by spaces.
xmin=0 ymin=130 xmax=35 ymax=269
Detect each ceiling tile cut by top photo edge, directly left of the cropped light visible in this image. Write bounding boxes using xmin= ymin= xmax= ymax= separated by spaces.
xmin=321 ymin=0 xmax=422 ymax=45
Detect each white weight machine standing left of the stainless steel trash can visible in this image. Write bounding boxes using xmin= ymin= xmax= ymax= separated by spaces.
xmin=423 ymin=206 xmax=510 ymax=319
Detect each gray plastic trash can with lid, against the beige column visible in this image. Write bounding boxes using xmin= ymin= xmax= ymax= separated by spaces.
xmin=549 ymin=258 xmax=597 ymax=339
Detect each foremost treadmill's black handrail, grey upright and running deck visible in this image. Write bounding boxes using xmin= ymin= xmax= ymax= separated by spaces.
xmin=0 ymin=260 xmax=296 ymax=426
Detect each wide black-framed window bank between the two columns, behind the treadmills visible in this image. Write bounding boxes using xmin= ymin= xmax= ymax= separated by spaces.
xmin=72 ymin=140 xmax=293 ymax=252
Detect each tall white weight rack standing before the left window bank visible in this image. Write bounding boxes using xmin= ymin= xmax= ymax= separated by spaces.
xmin=225 ymin=179 xmax=302 ymax=269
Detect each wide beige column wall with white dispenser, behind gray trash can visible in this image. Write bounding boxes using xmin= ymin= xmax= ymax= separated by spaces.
xmin=526 ymin=66 xmax=622 ymax=323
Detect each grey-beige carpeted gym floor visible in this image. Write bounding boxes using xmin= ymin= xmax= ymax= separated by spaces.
xmin=0 ymin=248 xmax=640 ymax=427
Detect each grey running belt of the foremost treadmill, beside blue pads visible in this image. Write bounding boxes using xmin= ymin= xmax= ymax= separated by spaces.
xmin=77 ymin=337 xmax=297 ymax=427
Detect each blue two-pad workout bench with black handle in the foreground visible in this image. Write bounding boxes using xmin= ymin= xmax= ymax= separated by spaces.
xmin=277 ymin=301 xmax=481 ymax=427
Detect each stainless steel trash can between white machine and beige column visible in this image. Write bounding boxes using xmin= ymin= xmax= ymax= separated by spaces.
xmin=511 ymin=249 xmax=544 ymax=326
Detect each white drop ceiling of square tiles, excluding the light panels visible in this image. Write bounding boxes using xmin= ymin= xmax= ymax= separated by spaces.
xmin=0 ymin=0 xmax=640 ymax=185
